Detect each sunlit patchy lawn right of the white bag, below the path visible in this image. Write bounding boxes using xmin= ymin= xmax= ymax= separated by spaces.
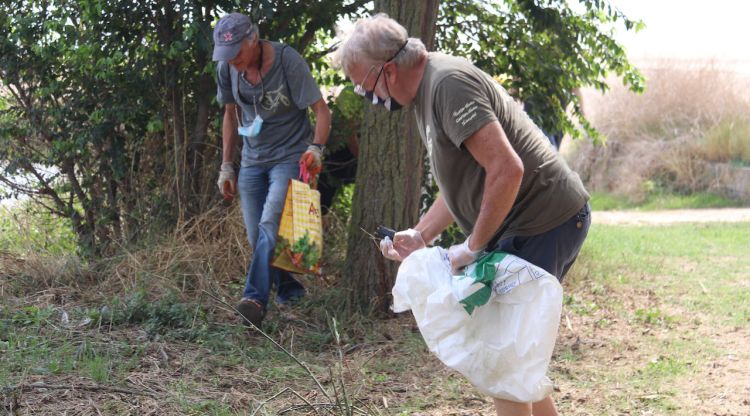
xmin=553 ymin=223 xmax=750 ymax=415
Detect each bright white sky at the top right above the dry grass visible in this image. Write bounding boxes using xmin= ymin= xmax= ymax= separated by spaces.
xmin=611 ymin=0 xmax=750 ymax=73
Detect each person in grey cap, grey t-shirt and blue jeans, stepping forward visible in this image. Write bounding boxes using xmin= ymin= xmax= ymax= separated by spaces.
xmin=213 ymin=13 xmax=331 ymax=327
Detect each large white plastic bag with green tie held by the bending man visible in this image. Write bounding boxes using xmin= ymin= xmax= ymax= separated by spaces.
xmin=393 ymin=247 xmax=562 ymax=402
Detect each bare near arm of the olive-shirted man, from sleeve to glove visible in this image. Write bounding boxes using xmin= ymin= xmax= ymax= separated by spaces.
xmin=464 ymin=121 xmax=523 ymax=251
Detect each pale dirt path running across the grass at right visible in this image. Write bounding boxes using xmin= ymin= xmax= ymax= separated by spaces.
xmin=591 ymin=208 xmax=750 ymax=225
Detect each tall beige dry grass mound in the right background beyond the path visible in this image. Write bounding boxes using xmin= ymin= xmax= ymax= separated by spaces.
xmin=570 ymin=61 xmax=750 ymax=201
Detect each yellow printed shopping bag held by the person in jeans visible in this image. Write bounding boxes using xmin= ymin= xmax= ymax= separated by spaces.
xmin=271 ymin=164 xmax=323 ymax=274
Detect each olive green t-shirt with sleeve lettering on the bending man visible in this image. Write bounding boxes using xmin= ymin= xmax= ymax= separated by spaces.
xmin=414 ymin=52 xmax=589 ymax=239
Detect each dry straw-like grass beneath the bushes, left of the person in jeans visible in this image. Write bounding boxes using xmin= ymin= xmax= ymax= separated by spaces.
xmin=0 ymin=204 xmax=250 ymax=300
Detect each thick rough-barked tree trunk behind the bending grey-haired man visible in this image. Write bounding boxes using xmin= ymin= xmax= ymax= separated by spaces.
xmin=346 ymin=0 xmax=439 ymax=314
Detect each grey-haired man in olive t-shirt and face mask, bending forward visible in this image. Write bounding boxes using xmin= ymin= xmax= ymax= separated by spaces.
xmin=334 ymin=14 xmax=590 ymax=416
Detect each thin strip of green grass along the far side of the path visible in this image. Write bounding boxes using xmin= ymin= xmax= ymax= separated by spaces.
xmin=590 ymin=192 xmax=741 ymax=211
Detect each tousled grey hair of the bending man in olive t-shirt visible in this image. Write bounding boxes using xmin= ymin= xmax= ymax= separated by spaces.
xmin=333 ymin=13 xmax=427 ymax=76
